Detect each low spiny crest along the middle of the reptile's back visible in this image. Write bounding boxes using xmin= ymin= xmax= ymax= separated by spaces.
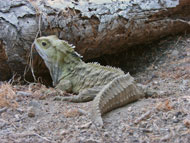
xmin=88 ymin=62 xmax=124 ymax=74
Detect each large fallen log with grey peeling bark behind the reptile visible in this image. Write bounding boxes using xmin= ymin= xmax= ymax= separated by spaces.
xmin=0 ymin=0 xmax=190 ymax=80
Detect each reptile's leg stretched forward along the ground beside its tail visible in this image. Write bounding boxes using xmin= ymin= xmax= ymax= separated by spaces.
xmin=54 ymin=87 xmax=102 ymax=103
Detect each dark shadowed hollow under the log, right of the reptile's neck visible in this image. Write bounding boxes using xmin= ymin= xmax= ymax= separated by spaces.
xmin=88 ymin=34 xmax=190 ymax=76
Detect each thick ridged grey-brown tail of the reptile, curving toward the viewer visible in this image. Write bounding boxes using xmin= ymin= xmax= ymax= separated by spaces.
xmin=90 ymin=74 xmax=144 ymax=126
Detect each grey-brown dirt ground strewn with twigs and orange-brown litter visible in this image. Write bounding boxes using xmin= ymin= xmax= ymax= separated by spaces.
xmin=0 ymin=35 xmax=190 ymax=143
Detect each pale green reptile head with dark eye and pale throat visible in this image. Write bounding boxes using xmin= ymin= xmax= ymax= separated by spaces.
xmin=34 ymin=35 xmax=81 ymax=84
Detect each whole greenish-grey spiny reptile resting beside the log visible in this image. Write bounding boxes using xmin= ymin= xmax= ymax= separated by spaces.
xmin=35 ymin=36 xmax=148 ymax=126
